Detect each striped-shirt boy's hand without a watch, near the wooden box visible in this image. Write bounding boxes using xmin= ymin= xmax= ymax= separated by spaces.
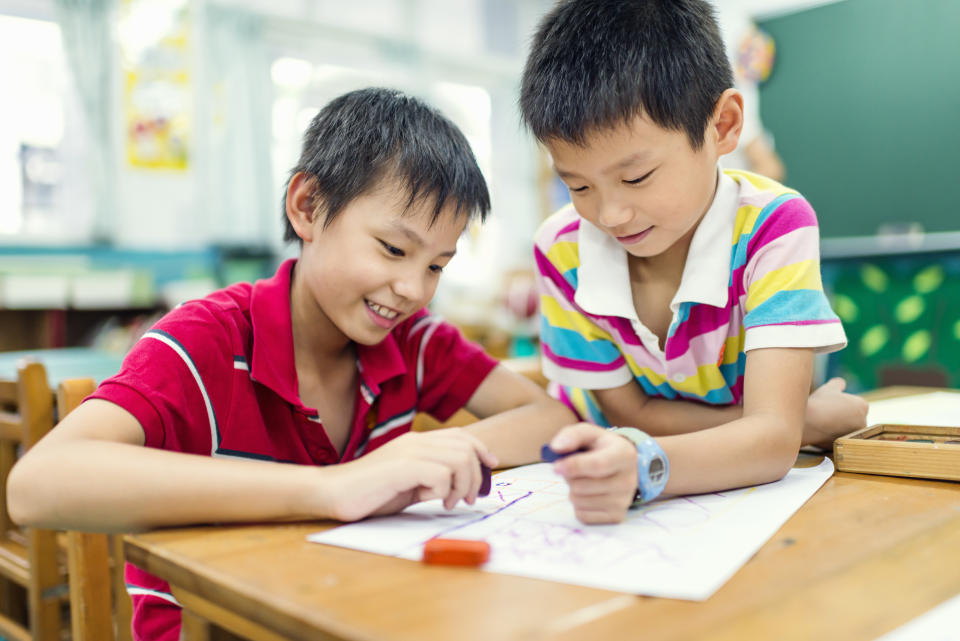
xmin=803 ymin=378 xmax=869 ymax=449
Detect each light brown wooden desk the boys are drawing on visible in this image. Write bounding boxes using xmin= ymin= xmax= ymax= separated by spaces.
xmin=125 ymin=390 xmax=960 ymax=641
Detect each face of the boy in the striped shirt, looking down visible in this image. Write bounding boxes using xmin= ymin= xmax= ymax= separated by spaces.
xmin=545 ymin=92 xmax=742 ymax=258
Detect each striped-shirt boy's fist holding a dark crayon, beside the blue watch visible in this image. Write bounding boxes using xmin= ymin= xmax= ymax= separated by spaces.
xmin=550 ymin=423 xmax=637 ymax=523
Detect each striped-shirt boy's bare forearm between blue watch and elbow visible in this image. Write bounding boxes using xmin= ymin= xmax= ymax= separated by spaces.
xmin=657 ymin=414 xmax=802 ymax=494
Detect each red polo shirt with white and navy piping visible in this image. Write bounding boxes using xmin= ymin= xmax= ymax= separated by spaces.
xmin=91 ymin=260 xmax=497 ymax=641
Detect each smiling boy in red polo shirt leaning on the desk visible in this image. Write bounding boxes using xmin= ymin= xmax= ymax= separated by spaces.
xmin=9 ymin=89 xmax=573 ymax=641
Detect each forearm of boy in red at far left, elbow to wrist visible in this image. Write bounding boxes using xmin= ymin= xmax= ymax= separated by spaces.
xmin=8 ymin=440 xmax=324 ymax=531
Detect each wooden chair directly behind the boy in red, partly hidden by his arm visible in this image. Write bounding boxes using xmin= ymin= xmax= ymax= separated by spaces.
xmin=57 ymin=378 xmax=132 ymax=641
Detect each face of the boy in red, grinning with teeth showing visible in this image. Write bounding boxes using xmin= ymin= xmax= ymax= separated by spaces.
xmin=288 ymin=172 xmax=467 ymax=345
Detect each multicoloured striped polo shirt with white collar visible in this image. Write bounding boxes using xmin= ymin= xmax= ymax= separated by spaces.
xmin=534 ymin=170 xmax=846 ymax=425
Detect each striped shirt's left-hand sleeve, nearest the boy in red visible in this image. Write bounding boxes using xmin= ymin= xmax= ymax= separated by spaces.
xmin=534 ymin=216 xmax=633 ymax=389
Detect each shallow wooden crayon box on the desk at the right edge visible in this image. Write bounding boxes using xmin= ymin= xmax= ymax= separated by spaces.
xmin=833 ymin=424 xmax=960 ymax=481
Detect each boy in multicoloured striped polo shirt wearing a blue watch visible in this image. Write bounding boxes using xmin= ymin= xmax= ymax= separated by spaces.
xmin=520 ymin=0 xmax=866 ymax=522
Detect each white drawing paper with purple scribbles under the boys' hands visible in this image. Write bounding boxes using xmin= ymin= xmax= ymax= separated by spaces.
xmin=308 ymin=458 xmax=833 ymax=601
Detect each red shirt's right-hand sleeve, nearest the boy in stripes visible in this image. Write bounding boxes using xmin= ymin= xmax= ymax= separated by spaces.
xmin=408 ymin=312 xmax=497 ymax=422
